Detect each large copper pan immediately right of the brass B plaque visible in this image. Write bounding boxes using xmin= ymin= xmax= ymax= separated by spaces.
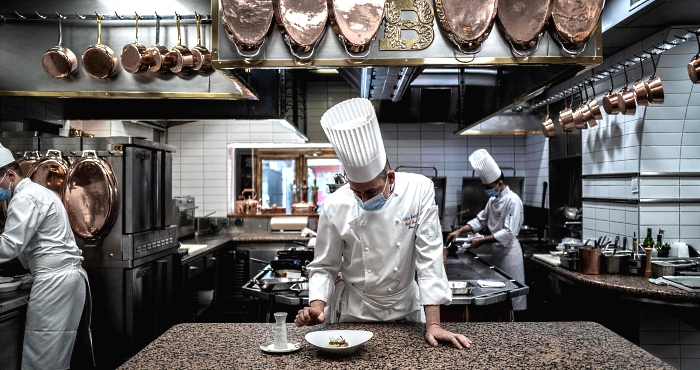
xmin=435 ymin=0 xmax=498 ymax=54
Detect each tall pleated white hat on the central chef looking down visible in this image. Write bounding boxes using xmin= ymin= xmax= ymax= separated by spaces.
xmin=321 ymin=98 xmax=386 ymax=183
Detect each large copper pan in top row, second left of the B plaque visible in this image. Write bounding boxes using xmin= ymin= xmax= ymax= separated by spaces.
xmin=273 ymin=0 xmax=328 ymax=61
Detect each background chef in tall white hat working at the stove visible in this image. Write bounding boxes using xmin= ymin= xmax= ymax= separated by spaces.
xmin=447 ymin=149 xmax=527 ymax=311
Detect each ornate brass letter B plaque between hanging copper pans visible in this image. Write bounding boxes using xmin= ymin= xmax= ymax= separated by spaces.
xmin=379 ymin=0 xmax=435 ymax=50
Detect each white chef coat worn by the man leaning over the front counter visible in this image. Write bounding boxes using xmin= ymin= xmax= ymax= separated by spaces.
xmin=307 ymin=172 xmax=452 ymax=322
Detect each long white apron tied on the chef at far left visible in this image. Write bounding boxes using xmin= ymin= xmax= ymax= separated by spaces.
xmin=22 ymin=255 xmax=95 ymax=370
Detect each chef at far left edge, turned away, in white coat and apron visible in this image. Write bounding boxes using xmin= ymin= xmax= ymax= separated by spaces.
xmin=0 ymin=145 xmax=89 ymax=370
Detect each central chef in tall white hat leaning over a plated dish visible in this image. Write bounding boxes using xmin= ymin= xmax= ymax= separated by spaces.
xmin=295 ymin=99 xmax=471 ymax=348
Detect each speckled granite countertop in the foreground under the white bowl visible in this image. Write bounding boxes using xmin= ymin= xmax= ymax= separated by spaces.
xmin=120 ymin=322 xmax=673 ymax=370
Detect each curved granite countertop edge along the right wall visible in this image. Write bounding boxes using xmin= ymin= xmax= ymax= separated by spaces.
xmin=532 ymin=258 xmax=700 ymax=303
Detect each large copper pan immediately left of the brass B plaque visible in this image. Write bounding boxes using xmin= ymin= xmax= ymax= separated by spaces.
xmin=328 ymin=0 xmax=386 ymax=58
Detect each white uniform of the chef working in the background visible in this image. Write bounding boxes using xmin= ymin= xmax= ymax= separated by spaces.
xmin=467 ymin=186 xmax=527 ymax=311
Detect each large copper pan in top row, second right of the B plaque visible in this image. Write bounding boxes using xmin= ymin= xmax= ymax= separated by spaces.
xmin=498 ymin=0 xmax=552 ymax=57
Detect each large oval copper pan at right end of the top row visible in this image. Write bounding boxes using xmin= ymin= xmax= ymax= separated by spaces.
xmin=551 ymin=0 xmax=605 ymax=56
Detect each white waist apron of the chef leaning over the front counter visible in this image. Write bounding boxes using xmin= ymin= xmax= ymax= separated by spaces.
xmin=326 ymin=280 xmax=425 ymax=323
